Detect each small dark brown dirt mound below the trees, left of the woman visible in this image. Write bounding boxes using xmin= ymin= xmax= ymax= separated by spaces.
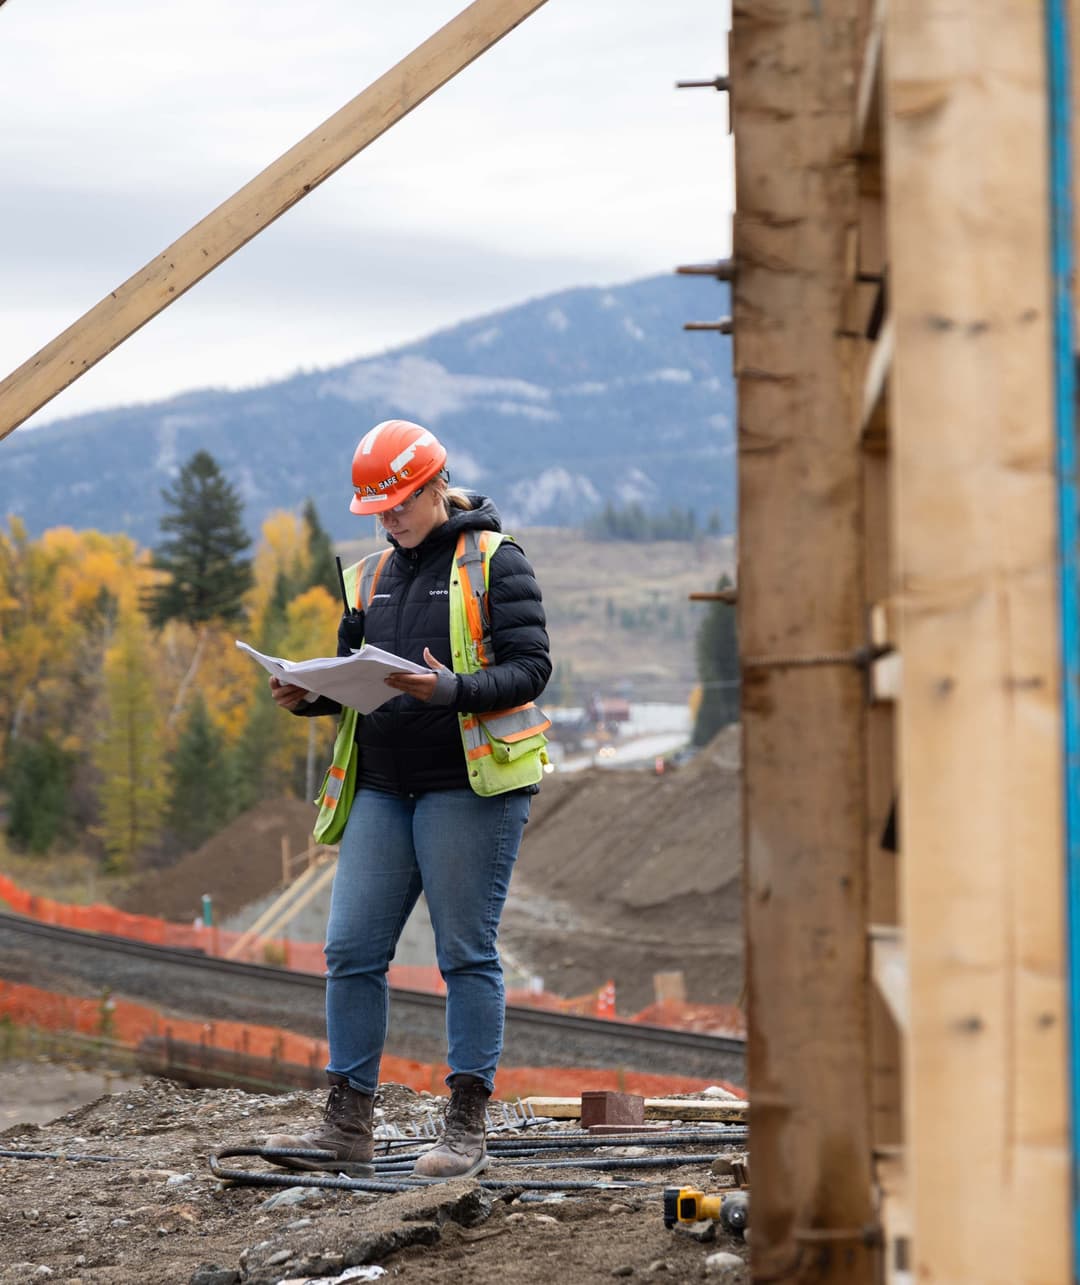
xmin=117 ymin=798 xmax=315 ymax=923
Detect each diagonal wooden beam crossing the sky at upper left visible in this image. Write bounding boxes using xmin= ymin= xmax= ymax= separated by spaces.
xmin=0 ymin=0 xmax=545 ymax=439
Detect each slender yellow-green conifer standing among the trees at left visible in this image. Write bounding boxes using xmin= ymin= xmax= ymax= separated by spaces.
xmin=93 ymin=610 xmax=165 ymax=870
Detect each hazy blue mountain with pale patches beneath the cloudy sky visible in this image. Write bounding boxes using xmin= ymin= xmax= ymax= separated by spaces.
xmin=0 ymin=276 xmax=734 ymax=545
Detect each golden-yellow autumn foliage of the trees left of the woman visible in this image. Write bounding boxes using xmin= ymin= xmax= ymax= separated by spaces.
xmin=0 ymin=511 xmax=341 ymax=817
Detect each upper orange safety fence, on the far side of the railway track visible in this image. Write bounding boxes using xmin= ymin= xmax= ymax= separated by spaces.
xmin=0 ymin=868 xmax=746 ymax=1036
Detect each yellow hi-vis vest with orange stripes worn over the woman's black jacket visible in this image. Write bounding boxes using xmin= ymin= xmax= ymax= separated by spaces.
xmin=312 ymin=531 xmax=552 ymax=843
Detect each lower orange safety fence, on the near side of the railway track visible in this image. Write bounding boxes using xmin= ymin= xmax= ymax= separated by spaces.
xmin=0 ymin=980 xmax=744 ymax=1099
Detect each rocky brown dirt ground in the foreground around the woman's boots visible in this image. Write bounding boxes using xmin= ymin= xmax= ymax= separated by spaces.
xmin=0 ymin=1067 xmax=750 ymax=1285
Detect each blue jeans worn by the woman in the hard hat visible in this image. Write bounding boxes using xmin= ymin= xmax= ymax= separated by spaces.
xmin=327 ymin=789 xmax=532 ymax=1094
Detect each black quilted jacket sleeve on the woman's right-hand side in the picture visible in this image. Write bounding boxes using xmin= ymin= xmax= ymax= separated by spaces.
xmin=454 ymin=540 xmax=552 ymax=713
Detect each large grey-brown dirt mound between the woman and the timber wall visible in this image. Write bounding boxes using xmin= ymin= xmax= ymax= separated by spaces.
xmin=501 ymin=727 xmax=742 ymax=1013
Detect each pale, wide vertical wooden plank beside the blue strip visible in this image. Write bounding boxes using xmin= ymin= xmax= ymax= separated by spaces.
xmin=885 ymin=0 xmax=1072 ymax=1285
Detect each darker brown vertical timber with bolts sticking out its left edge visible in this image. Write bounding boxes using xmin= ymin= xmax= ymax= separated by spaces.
xmin=729 ymin=0 xmax=878 ymax=1285
